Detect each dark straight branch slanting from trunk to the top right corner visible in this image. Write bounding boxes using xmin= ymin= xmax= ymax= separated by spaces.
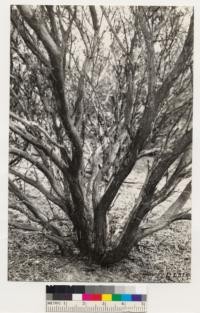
xmin=94 ymin=11 xmax=193 ymax=217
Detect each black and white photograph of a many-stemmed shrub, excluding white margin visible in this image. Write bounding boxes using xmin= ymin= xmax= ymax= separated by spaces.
xmin=8 ymin=3 xmax=194 ymax=283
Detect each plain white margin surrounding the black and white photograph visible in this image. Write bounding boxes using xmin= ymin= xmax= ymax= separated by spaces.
xmin=0 ymin=0 xmax=200 ymax=313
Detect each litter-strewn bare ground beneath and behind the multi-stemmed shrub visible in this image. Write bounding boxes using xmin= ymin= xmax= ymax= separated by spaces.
xmin=8 ymin=158 xmax=191 ymax=283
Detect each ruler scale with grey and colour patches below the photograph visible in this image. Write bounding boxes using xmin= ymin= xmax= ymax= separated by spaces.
xmin=46 ymin=285 xmax=147 ymax=313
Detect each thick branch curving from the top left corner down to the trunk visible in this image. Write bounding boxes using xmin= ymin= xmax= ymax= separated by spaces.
xmin=18 ymin=6 xmax=83 ymax=175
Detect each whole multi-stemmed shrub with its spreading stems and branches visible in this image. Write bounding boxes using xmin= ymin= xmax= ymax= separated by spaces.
xmin=10 ymin=6 xmax=193 ymax=265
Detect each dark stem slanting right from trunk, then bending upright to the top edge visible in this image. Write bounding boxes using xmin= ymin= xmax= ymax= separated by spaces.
xmin=96 ymin=8 xmax=156 ymax=218
